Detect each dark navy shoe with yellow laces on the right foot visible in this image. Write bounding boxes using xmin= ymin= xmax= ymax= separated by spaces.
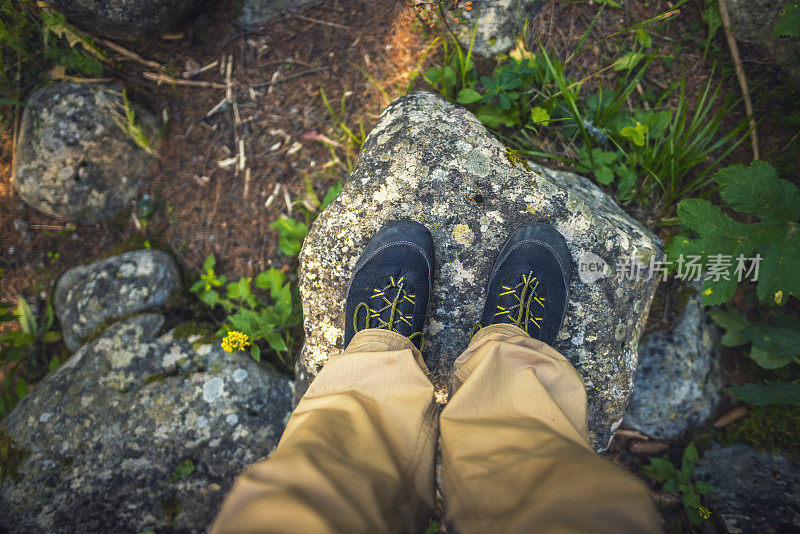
xmin=477 ymin=223 xmax=572 ymax=345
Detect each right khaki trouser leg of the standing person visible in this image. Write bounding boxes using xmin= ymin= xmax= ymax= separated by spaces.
xmin=440 ymin=325 xmax=661 ymax=534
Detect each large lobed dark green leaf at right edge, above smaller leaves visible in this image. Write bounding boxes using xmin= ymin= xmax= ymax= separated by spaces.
xmin=667 ymin=161 xmax=800 ymax=305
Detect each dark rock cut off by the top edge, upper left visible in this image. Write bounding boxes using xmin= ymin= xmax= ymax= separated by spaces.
xmin=51 ymin=0 xmax=204 ymax=41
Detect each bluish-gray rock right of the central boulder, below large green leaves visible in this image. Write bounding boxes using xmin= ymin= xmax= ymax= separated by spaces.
xmin=624 ymin=288 xmax=722 ymax=439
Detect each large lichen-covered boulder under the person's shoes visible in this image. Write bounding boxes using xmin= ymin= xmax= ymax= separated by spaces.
xmin=297 ymin=92 xmax=662 ymax=449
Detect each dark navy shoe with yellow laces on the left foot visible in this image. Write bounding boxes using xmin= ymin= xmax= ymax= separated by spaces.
xmin=344 ymin=220 xmax=434 ymax=349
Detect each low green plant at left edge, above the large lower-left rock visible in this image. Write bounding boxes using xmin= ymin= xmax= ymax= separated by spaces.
xmin=0 ymin=295 xmax=61 ymax=418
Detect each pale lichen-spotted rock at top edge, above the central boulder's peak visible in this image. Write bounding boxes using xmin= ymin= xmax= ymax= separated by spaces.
xmin=455 ymin=0 xmax=543 ymax=57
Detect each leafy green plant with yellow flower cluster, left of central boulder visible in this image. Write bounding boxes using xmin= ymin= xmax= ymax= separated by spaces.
xmin=190 ymin=254 xmax=302 ymax=368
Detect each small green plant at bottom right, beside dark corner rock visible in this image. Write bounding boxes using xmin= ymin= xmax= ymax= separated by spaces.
xmin=641 ymin=443 xmax=714 ymax=527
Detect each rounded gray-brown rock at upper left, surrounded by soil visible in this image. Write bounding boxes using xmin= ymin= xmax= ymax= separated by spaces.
xmin=14 ymin=82 xmax=156 ymax=223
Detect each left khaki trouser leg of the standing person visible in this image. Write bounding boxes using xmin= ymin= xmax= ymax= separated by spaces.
xmin=212 ymin=330 xmax=437 ymax=533
